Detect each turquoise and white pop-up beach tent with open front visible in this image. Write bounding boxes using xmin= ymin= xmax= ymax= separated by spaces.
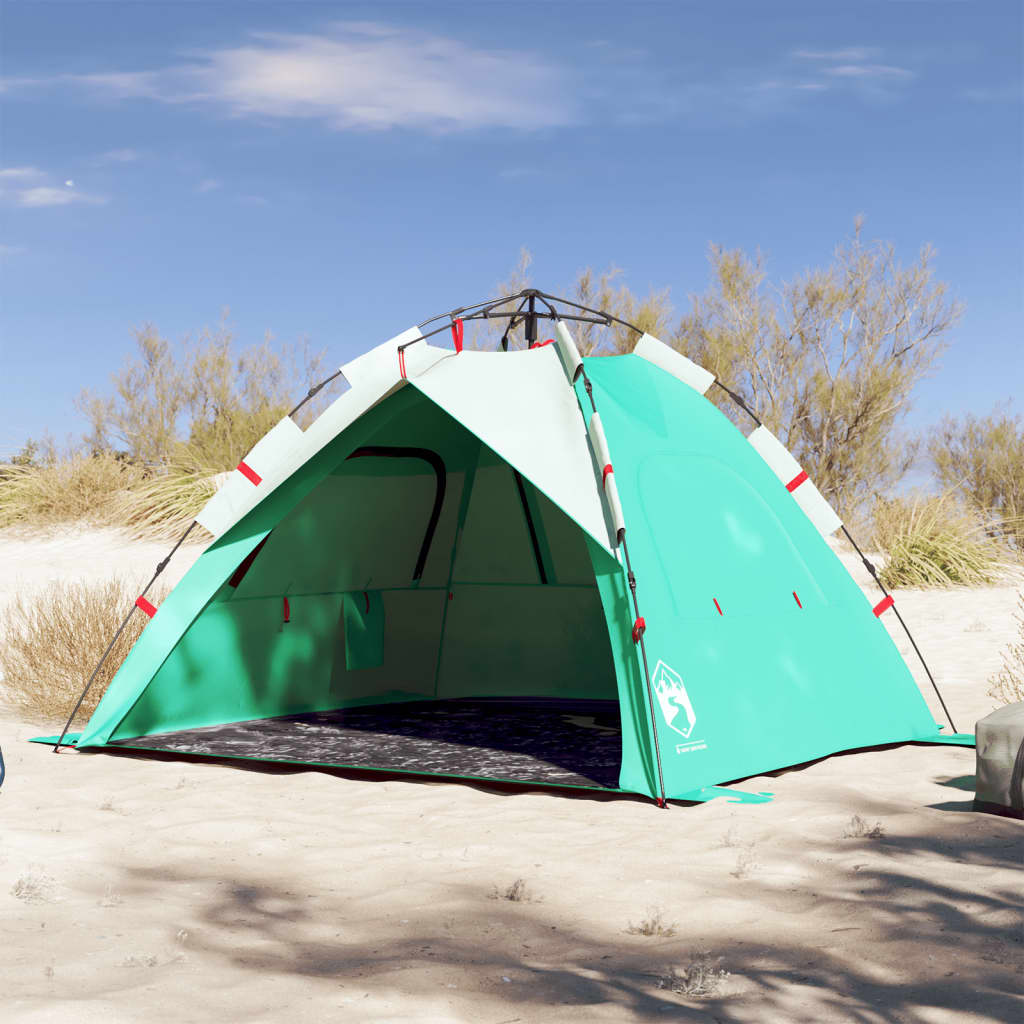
xmin=46 ymin=291 xmax=971 ymax=802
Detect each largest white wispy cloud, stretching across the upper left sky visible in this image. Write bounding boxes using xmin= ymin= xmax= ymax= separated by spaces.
xmin=7 ymin=23 xmax=573 ymax=131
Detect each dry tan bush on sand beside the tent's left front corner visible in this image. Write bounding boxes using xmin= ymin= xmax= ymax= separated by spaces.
xmin=0 ymin=578 xmax=163 ymax=722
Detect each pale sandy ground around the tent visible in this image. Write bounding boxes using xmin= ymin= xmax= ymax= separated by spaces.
xmin=0 ymin=531 xmax=1024 ymax=1024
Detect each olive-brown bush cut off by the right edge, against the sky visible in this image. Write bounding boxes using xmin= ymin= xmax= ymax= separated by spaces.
xmin=928 ymin=410 xmax=1024 ymax=557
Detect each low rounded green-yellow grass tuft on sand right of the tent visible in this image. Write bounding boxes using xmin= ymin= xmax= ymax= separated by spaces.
xmin=873 ymin=496 xmax=1008 ymax=588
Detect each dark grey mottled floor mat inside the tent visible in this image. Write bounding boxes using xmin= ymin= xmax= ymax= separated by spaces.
xmin=108 ymin=698 xmax=622 ymax=790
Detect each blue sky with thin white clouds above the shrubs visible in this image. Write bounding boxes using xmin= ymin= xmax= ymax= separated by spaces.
xmin=0 ymin=0 xmax=1024 ymax=455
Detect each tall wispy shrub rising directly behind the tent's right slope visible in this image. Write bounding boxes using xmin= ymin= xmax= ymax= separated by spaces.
xmin=675 ymin=221 xmax=961 ymax=517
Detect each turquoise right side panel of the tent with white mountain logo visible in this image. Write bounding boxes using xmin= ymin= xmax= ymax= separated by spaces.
xmin=586 ymin=355 xmax=936 ymax=796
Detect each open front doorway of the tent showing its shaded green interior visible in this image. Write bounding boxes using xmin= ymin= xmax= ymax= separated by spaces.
xmin=113 ymin=389 xmax=622 ymax=788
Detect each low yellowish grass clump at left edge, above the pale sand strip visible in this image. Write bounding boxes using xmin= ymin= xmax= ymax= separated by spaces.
xmin=0 ymin=452 xmax=142 ymax=526
